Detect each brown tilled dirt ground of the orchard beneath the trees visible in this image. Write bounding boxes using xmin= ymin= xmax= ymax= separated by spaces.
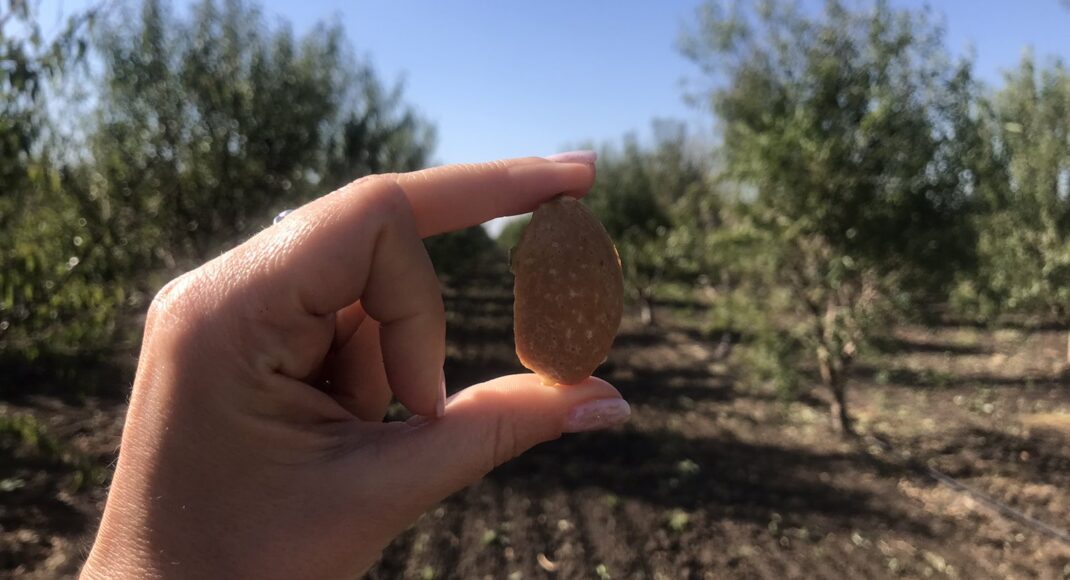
xmin=0 ymin=269 xmax=1070 ymax=580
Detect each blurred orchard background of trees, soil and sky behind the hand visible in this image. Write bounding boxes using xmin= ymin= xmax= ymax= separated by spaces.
xmin=0 ymin=0 xmax=1070 ymax=580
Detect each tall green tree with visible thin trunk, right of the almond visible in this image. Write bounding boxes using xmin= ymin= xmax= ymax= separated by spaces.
xmin=683 ymin=0 xmax=976 ymax=433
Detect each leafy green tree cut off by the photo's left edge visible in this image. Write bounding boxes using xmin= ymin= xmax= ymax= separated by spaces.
xmin=0 ymin=0 xmax=110 ymax=358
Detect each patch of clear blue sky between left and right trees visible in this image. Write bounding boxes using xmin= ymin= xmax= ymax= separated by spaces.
xmin=295 ymin=0 xmax=706 ymax=163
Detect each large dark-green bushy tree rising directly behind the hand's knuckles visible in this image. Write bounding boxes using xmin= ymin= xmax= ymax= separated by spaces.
xmin=90 ymin=0 xmax=433 ymax=271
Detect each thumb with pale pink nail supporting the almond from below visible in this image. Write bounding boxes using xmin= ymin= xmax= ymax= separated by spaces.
xmin=385 ymin=375 xmax=630 ymax=513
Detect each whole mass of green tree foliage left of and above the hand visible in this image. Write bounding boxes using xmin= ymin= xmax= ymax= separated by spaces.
xmin=0 ymin=0 xmax=434 ymax=357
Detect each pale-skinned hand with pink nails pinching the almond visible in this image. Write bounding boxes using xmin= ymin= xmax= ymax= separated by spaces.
xmin=82 ymin=154 xmax=628 ymax=579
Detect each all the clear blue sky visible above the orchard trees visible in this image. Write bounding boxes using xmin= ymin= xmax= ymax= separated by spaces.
xmin=43 ymin=0 xmax=1070 ymax=163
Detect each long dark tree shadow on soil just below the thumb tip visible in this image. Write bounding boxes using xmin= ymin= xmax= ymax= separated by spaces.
xmin=490 ymin=429 xmax=928 ymax=533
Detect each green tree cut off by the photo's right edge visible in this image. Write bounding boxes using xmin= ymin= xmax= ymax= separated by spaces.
xmin=978 ymin=54 xmax=1070 ymax=363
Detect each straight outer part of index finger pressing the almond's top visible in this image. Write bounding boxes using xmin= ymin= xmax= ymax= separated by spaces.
xmin=397 ymin=152 xmax=595 ymax=238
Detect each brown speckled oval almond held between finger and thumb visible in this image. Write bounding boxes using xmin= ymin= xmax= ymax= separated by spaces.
xmin=511 ymin=196 xmax=624 ymax=384
